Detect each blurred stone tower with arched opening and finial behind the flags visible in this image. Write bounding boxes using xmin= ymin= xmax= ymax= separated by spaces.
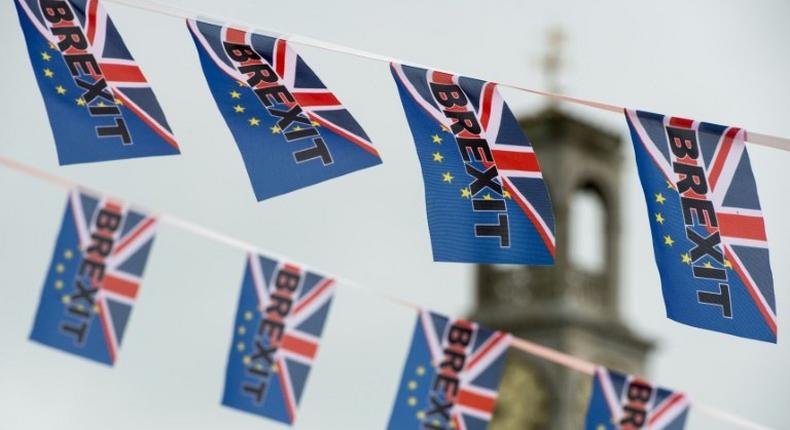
xmin=472 ymin=29 xmax=652 ymax=430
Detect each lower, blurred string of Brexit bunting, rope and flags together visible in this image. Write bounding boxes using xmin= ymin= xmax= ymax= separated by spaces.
xmin=0 ymin=156 xmax=772 ymax=430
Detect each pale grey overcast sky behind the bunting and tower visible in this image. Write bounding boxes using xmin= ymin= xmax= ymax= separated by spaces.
xmin=0 ymin=0 xmax=790 ymax=430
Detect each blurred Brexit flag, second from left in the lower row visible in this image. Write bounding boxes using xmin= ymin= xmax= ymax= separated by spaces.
xmin=222 ymin=254 xmax=335 ymax=424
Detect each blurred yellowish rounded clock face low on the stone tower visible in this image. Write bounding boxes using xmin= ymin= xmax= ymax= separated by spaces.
xmin=489 ymin=353 xmax=551 ymax=430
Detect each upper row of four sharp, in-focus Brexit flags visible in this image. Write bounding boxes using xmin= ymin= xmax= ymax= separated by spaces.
xmin=15 ymin=0 xmax=777 ymax=342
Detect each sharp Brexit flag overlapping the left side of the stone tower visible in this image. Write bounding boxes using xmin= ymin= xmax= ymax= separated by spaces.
xmin=391 ymin=63 xmax=555 ymax=264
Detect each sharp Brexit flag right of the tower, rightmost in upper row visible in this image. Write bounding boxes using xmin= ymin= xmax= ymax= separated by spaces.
xmin=625 ymin=110 xmax=777 ymax=342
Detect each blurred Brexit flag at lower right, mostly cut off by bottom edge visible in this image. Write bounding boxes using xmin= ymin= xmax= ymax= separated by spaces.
xmin=584 ymin=367 xmax=690 ymax=430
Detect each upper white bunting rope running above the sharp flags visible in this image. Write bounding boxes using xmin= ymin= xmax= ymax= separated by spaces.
xmin=104 ymin=0 xmax=790 ymax=151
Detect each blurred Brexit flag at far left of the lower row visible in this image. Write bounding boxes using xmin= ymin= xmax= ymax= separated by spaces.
xmin=30 ymin=191 xmax=156 ymax=365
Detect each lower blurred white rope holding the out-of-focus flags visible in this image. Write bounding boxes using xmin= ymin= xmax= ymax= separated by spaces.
xmin=0 ymin=156 xmax=774 ymax=430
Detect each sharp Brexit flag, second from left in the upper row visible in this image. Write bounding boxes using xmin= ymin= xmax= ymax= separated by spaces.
xmin=187 ymin=20 xmax=381 ymax=201
